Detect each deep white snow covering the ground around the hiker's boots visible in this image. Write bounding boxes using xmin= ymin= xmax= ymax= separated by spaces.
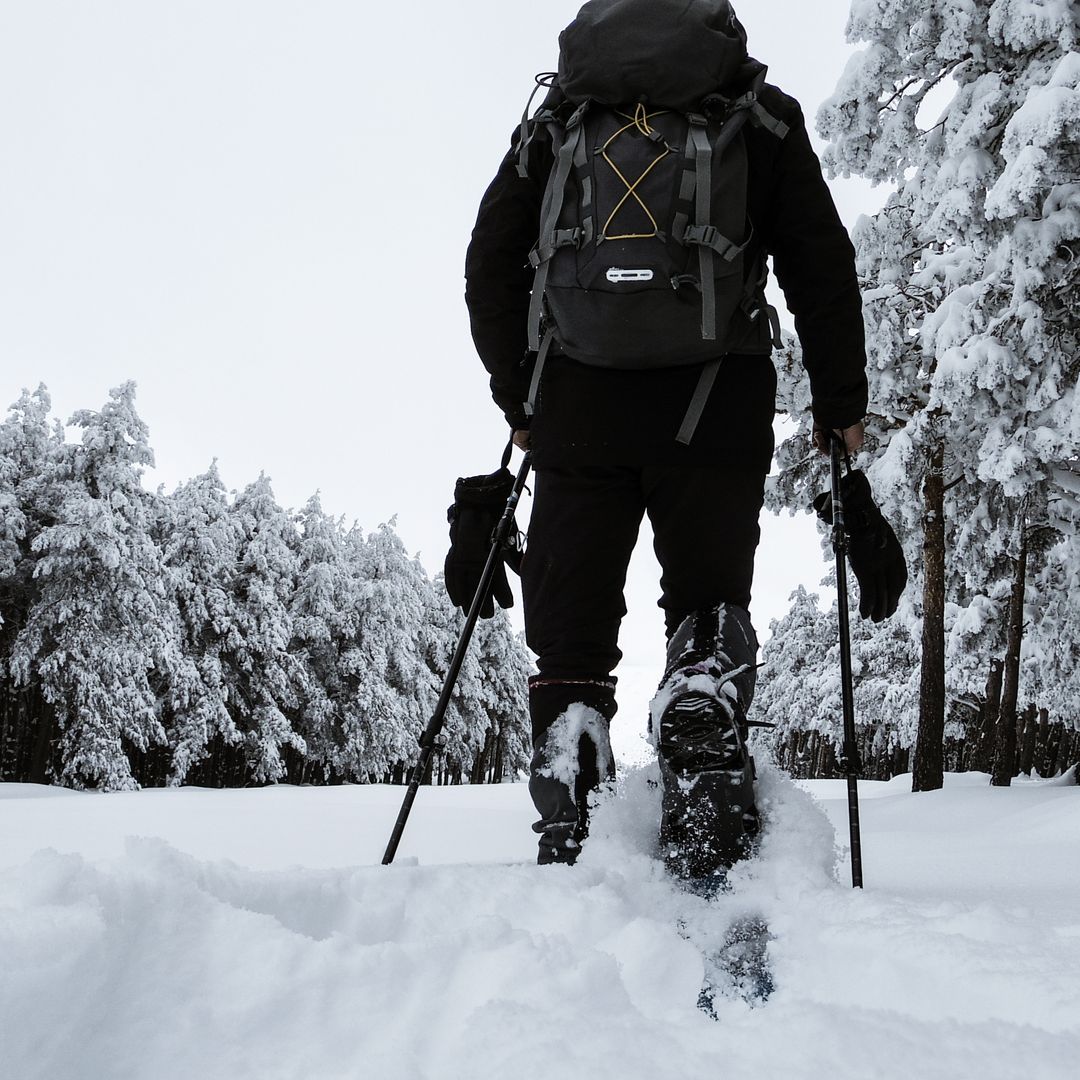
xmin=0 ymin=767 xmax=1080 ymax=1080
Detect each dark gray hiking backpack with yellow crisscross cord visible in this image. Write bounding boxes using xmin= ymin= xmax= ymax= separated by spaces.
xmin=518 ymin=0 xmax=787 ymax=443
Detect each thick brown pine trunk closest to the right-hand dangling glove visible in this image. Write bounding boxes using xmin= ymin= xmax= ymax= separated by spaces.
xmin=912 ymin=441 xmax=945 ymax=792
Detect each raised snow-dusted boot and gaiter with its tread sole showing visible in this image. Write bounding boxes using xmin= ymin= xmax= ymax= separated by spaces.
xmin=650 ymin=606 xmax=759 ymax=879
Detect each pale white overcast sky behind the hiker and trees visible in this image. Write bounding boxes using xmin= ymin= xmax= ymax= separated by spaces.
xmin=0 ymin=0 xmax=882 ymax=686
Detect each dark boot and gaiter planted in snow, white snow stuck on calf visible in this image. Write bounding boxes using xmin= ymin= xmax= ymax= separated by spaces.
xmin=529 ymin=675 xmax=616 ymax=865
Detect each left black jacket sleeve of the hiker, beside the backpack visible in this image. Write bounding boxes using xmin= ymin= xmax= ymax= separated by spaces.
xmin=465 ymin=138 xmax=542 ymax=429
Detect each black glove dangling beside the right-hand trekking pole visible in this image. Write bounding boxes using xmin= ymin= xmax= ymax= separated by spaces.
xmin=813 ymin=469 xmax=907 ymax=622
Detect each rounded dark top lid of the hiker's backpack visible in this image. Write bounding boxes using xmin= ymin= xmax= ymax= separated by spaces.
xmin=558 ymin=0 xmax=760 ymax=111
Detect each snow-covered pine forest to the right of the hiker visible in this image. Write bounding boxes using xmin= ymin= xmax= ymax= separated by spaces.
xmin=756 ymin=0 xmax=1080 ymax=791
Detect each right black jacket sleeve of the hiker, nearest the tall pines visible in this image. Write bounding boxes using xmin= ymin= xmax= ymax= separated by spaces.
xmin=766 ymin=110 xmax=867 ymax=428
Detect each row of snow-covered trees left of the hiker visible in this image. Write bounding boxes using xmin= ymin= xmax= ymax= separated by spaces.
xmin=0 ymin=383 xmax=531 ymax=791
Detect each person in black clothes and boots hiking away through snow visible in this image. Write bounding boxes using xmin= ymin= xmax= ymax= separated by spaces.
xmin=465 ymin=0 xmax=867 ymax=878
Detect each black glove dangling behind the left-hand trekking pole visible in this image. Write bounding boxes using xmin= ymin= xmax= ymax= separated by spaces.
xmin=443 ymin=468 xmax=522 ymax=619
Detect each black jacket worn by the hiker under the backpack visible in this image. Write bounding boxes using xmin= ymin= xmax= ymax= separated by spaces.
xmin=465 ymin=76 xmax=866 ymax=467
